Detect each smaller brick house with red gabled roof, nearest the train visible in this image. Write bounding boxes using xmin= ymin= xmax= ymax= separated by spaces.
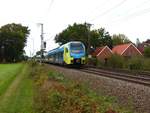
xmin=92 ymin=46 xmax=113 ymax=62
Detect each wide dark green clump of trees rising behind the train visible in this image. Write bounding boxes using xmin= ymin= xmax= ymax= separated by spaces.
xmin=55 ymin=23 xmax=112 ymax=53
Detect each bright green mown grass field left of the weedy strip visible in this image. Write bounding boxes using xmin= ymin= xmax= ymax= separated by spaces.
xmin=0 ymin=63 xmax=33 ymax=113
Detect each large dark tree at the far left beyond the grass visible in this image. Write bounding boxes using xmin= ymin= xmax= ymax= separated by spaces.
xmin=0 ymin=23 xmax=29 ymax=62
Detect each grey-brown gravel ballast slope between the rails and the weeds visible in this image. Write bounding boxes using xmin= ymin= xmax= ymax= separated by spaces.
xmin=49 ymin=65 xmax=150 ymax=113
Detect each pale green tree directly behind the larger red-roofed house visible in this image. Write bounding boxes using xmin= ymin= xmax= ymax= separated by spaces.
xmin=112 ymin=34 xmax=131 ymax=46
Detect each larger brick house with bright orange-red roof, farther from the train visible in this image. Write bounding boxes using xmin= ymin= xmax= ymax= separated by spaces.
xmin=112 ymin=43 xmax=142 ymax=58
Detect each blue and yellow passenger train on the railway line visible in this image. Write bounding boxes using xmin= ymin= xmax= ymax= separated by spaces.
xmin=45 ymin=41 xmax=86 ymax=65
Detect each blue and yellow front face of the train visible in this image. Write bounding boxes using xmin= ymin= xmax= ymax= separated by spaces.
xmin=70 ymin=42 xmax=85 ymax=64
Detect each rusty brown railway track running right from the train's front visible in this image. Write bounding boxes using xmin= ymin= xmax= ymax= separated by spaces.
xmin=80 ymin=67 xmax=150 ymax=87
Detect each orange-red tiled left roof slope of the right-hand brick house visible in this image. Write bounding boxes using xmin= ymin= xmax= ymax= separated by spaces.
xmin=112 ymin=43 xmax=131 ymax=55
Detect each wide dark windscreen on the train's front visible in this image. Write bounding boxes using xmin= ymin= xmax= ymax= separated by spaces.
xmin=70 ymin=43 xmax=84 ymax=53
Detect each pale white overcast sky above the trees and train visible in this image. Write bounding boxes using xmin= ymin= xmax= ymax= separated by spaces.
xmin=0 ymin=0 xmax=150 ymax=55
